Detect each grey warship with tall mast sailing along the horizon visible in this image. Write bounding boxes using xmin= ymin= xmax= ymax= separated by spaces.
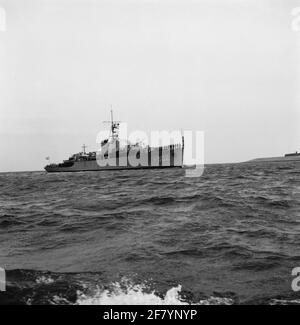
xmin=45 ymin=110 xmax=184 ymax=173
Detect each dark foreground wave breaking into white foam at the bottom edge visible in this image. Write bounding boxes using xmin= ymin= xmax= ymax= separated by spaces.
xmin=0 ymin=270 xmax=235 ymax=305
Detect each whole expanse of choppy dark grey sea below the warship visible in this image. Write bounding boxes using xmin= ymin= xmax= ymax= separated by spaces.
xmin=0 ymin=162 xmax=300 ymax=304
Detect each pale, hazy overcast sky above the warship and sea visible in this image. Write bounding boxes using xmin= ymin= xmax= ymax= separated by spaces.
xmin=0 ymin=0 xmax=300 ymax=172
